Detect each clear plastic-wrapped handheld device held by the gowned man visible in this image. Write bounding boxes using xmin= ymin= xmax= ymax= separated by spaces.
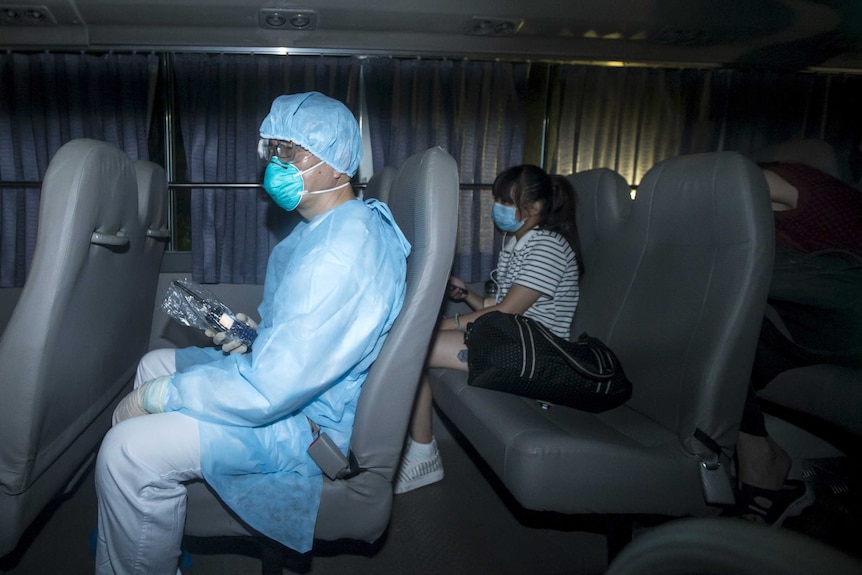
xmin=162 ymin=279 xmax=257 ymax=349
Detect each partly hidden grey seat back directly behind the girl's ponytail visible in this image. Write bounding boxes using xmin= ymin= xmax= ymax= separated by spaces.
xmin=568 ymin=168 xmax=632 ymax=269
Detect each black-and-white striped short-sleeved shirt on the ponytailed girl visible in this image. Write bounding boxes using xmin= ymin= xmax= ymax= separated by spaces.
xmin=492 ymin=229 xmax=579 ymax=339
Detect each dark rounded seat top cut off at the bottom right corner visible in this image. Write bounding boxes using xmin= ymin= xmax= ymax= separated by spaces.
xmin=605 ymin=517 xmax=862 ymax=575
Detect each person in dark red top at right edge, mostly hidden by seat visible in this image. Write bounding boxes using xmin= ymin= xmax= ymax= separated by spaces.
xmin=736 ymin=163 xmax=862 ymax=525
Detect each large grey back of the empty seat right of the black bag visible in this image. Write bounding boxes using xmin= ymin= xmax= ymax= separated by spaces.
xmin=573 ymin=152 xmax=774 ymax=462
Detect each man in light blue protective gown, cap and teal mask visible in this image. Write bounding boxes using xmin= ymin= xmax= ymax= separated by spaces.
xmin=96 ymin=92 xmax=410 ymax=575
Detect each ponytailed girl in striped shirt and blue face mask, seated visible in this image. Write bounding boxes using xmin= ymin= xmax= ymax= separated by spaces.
xmin=395 ymin=164 xmax=584 ymax=493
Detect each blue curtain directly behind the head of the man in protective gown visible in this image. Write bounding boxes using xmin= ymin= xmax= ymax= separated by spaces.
xmin=172 ymin=54 xmax=359 ymax=283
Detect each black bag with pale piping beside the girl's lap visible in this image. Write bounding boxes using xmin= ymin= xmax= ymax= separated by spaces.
xmin=464 ymin=311 xmax=632 ymax=413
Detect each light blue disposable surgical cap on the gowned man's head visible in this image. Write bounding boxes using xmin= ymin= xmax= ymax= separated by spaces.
xmin=260 ymin=92 xmax=362 ymax=177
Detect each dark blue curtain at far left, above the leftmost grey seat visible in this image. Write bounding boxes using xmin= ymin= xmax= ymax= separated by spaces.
xmin=0 ymin=53 xmax=158 ymax=287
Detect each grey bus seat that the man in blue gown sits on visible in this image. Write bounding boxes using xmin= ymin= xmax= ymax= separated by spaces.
xmin=186 ymin=147 xmax=458 ymax=573
